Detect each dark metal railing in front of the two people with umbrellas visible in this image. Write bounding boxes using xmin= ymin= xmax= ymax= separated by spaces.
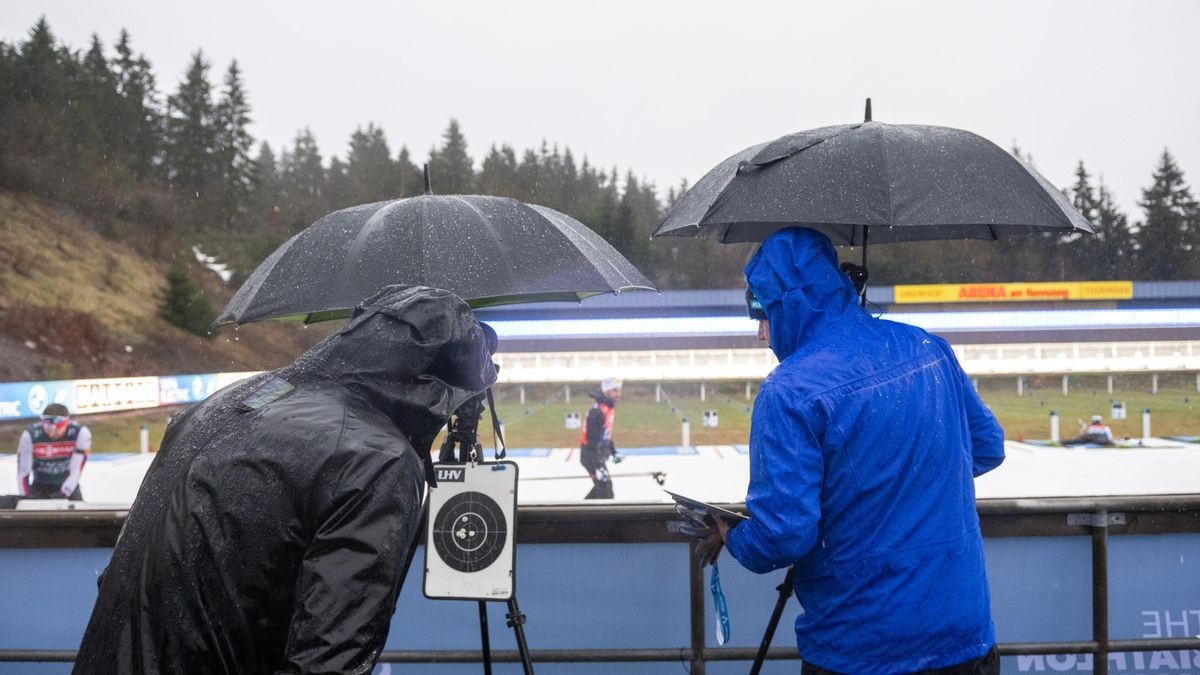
xmin=0 ymin=495 xmax=1200 ymax=675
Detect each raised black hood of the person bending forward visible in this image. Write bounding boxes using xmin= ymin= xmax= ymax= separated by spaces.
xmin=278 ymin=286 xmax=496 ymax=452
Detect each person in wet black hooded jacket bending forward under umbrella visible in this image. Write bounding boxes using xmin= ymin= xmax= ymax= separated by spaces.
xmin=74 ymin=286 xmax=496 ymax=674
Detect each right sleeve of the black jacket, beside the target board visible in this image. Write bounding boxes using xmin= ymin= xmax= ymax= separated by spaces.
xmin=281 ymin=449 xmax=420 ymax=674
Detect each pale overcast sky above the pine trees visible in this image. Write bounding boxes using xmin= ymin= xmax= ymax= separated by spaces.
xmin=0 ymin=0 xmax=1200 ymax=220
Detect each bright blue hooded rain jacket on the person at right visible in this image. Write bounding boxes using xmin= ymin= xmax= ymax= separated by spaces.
xmin=728 ymin=228 xmax=1004 ymax=674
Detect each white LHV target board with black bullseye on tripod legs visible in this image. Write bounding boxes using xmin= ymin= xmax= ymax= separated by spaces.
xmin=425 ymin=461 xmax=533 ymax=675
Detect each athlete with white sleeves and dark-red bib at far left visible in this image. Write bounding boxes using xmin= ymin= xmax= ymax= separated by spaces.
xmin=17 ymin=404 xmax=91 ymax=502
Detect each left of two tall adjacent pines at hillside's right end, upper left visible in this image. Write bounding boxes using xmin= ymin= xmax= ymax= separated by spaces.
xmin=166 ymin=52 xmax=220 ymax=201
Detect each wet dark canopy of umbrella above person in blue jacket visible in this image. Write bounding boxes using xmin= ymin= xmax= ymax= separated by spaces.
xmin=654 ymin=100 xmax=1092 ymax=245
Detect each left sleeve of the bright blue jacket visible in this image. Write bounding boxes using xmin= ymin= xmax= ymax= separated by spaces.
xmin=728 ymin=386 xmax=824 ymax=574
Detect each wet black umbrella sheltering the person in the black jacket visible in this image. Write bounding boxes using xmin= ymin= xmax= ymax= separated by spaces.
xmin=214 ymin=171 xmax=655 ymax=325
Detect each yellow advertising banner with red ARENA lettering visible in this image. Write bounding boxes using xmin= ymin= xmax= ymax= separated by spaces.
xmin=895 ymin=281 xmax=1133 ymax=304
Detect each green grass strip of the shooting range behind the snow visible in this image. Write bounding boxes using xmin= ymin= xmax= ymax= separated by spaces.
xmin=0 ymin=374 xmax=1200 ymax=453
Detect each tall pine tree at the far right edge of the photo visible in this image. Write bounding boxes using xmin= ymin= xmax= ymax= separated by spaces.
xmin=1135 ymin=150 xmax=1200 ymax=280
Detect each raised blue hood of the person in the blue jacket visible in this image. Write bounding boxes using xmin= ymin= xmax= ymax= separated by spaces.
xmin=745 ymin=227 xmax=859 ymax=360
